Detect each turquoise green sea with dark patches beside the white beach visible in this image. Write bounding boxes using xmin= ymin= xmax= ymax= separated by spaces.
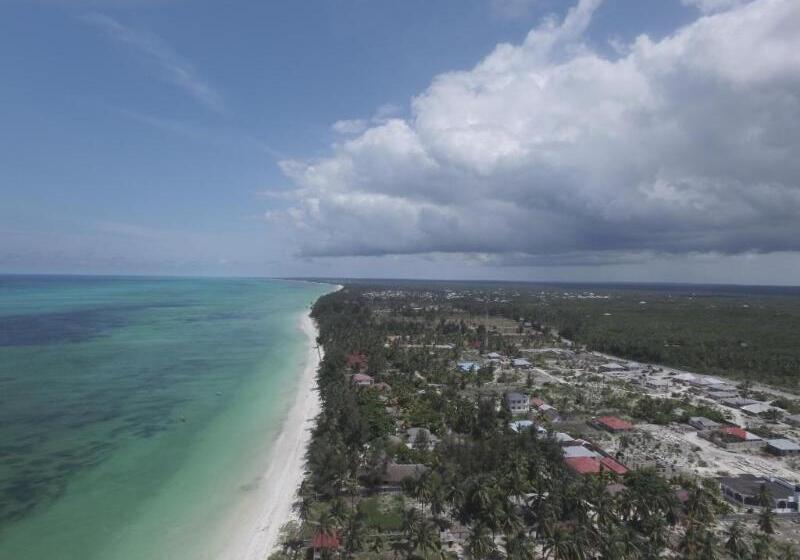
xmin=0 ymin=277 xmax=331 ymax=560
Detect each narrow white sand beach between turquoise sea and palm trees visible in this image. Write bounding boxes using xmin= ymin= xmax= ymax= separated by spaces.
xmin=228 ymin=314 xmax=321 ymax=560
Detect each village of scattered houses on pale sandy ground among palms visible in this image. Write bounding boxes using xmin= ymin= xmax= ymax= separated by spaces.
xmin=276 ymin=289 xmax=800 ymax=558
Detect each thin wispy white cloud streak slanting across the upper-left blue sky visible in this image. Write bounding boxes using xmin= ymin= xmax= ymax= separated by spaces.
xmin=81 ymin=13 xmax=224 ymax=112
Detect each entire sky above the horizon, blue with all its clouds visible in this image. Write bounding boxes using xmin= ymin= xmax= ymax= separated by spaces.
xmin=0 ymin=0 xmax=800 ymax=285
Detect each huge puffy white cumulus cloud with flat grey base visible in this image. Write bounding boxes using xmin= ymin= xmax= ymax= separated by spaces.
xmin=270 ymin=0 xmax=800 ymax=263
